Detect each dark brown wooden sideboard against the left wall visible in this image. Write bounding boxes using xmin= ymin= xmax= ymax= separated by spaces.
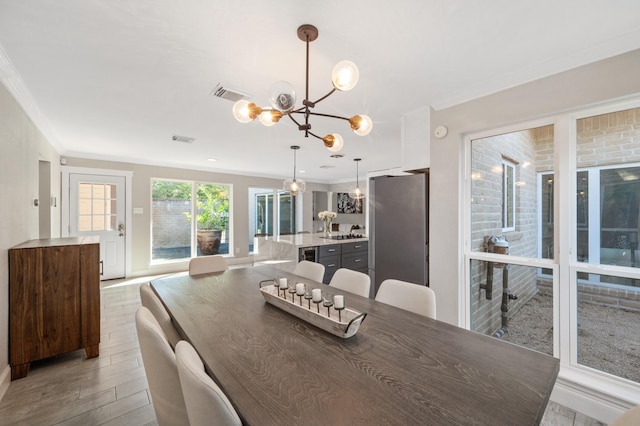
xmin=9 ymin=237 xmax=100 ymax=380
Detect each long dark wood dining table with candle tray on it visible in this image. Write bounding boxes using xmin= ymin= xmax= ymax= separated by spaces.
xmin=151 ymin=266 xmax=559 ymax=425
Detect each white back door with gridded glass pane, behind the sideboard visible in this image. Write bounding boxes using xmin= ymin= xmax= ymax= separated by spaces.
xmin=69 ymin=173 xmax=127 ymax=280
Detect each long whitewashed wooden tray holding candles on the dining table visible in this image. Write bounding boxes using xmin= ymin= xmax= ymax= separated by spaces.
xmin=260 ymin=280 xmax=367 ymax=339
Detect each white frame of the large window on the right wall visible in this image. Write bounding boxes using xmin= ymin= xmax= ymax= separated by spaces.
xmin=459 ymin=96 xmax=640 ymax=410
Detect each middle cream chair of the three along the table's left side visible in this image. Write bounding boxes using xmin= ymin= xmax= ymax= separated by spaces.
xmin=136 ymin=306 xmax=189 ymax=426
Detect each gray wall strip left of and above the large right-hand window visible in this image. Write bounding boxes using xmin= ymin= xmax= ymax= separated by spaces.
xmin=429 ymin=50 xmax=640 ymax=324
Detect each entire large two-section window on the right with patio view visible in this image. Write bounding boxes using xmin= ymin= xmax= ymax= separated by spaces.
xmin=465 ymin=100 xmax=640 ymax=393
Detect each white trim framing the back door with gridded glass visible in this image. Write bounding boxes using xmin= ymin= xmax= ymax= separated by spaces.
xmin=60 ymin=166 xmax=133 ymax=277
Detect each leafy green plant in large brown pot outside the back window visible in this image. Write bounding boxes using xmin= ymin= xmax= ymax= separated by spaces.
xmin=187 ymin=185 xmax=229 ymax=255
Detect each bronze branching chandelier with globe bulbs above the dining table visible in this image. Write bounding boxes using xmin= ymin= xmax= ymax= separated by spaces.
xmin=233 ymin=24 xmax=373 ymax=152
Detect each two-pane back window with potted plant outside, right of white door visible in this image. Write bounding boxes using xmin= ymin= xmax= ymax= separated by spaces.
xmin=151 ymin=179 xmax=231 ymax=261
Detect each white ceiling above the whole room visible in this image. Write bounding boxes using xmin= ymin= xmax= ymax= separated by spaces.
xmin=0 ymin=0 xmax=640 ymax=183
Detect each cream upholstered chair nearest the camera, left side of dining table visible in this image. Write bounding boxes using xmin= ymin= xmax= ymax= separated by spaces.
xmin=176 ymin=340 xmax=242 ymax=426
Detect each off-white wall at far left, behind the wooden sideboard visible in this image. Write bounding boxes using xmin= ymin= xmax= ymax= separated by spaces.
xmin=0 ymin=84 xmax=60 ymax=398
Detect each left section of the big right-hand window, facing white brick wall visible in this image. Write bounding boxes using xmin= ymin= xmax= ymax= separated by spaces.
xmin=467 ymin=125 xmax=558 ymax=355
